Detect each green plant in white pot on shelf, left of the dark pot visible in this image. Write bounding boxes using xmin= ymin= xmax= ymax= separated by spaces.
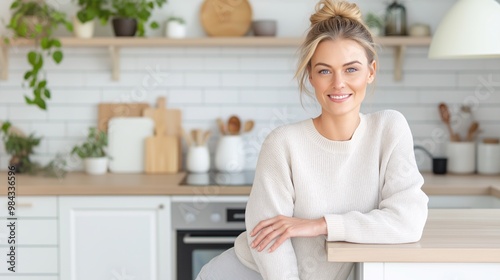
xmin=73 ymin=0 xmax=110 ymax=38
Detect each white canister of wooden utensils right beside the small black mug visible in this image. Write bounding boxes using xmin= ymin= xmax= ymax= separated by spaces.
xmin=447 ymin=142 xmax=476 ymax=174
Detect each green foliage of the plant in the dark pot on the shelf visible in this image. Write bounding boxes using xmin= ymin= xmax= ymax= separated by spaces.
xmin=111 ymin=0 xmax=167 ymax=37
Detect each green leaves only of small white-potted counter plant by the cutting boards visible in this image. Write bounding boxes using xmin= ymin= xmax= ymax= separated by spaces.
xmin=71 ymin=127 xmax=108 ymax=159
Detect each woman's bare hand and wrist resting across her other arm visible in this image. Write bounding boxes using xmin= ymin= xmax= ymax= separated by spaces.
xmin=250 ymin=215 xmax=328 ymax=253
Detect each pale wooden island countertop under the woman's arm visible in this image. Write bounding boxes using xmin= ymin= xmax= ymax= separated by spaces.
xmin=326 ymin=209 xmax=500 ymax=263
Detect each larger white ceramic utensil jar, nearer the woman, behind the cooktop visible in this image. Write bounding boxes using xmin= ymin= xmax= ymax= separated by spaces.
xmin=215 ymin=135 xmax=245 ymax=172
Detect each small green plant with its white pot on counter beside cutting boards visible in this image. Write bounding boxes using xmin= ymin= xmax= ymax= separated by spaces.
xmin=71 ymin=127 xmax=108 ymax=175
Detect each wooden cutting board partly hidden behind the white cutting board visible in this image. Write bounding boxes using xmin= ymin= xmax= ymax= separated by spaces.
xmin=97 ymin=103 xmax=149 ymax=132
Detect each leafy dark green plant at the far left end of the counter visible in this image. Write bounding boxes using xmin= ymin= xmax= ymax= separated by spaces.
xmin=1 ymin=122 xmax=41 ymax=173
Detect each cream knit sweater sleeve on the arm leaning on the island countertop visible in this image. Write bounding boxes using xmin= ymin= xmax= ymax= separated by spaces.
xmin=325 ymin=115 xmax=428 ymax=243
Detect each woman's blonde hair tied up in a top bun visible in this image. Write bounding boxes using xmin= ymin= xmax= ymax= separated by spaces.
xmin=295 ymin=0 xmax=377 ymax=98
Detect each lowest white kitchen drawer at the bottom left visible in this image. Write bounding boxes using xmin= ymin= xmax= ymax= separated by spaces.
xmin=0 ymin=246 xmax=58 ymax=274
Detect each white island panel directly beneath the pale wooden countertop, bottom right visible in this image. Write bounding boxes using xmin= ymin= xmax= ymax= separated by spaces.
xmin=360 ymin=263 xmax=500 ymax=280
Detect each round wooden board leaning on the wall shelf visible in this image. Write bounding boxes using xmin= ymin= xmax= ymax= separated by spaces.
xmin=200 ymin=0 xmax=252 ymax=37
